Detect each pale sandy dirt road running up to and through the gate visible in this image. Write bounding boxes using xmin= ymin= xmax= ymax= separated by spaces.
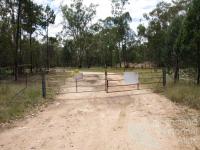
xmin=0 ymin=72 xmax=200 ymax=150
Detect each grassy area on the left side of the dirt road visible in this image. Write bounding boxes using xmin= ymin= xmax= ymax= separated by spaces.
xmin=0 ymin=73 xmax=71 ymax=123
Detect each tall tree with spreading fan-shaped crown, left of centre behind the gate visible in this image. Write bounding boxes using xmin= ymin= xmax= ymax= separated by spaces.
xmin=62 ymin=0 xmax=96 ymax=67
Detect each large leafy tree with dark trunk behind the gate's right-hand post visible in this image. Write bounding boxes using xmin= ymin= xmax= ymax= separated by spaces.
xmin=138 ymin=0 xmax=194 ymax=82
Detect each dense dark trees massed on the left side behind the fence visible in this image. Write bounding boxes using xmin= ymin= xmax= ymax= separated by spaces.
xmin=0 ymin=0 xmax=59 ymax=74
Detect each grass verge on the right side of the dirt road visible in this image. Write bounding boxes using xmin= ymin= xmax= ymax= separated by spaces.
xmin=164 ymin=82 xmax=200 ymax=110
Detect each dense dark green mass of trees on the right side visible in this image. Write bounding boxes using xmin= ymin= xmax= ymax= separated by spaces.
xmin=138 ymin=0 xmax=200 ymax=84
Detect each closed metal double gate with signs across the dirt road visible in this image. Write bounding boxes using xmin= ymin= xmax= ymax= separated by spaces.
xmin=60 ymin=71 xmax=166 ymax=93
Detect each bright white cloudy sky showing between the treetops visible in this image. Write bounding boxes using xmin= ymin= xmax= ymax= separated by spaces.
xmin=33 ymin=0 xmax=171 ymax=36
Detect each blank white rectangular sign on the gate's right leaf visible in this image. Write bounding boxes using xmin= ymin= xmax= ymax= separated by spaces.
xmin=124 ymin=72 xmax=139 ymax=84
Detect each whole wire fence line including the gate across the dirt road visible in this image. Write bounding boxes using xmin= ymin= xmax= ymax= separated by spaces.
xmin=0 ymin=68 xmax=195 ymax=99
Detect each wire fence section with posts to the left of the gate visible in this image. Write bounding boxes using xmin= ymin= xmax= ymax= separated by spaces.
xmin=0 ymin=72 xmax=70 ymax=101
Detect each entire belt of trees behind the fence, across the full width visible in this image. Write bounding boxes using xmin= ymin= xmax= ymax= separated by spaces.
xmin=0 ymin=0 xmax=200 ymax=84
